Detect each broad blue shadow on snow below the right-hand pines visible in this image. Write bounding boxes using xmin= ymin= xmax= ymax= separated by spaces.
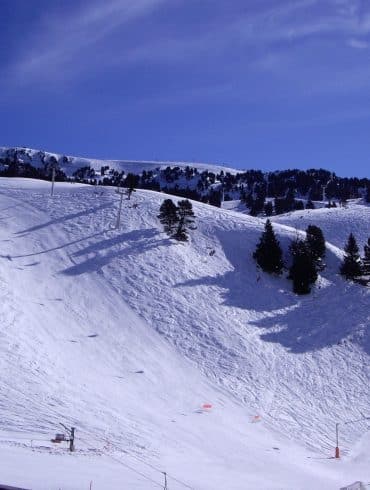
xmin=177 ymin=232 xmax=370 ymax=354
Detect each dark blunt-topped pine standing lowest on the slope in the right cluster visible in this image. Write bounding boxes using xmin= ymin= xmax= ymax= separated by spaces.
xmin=289 ymin=240 xmax=317 ymax=294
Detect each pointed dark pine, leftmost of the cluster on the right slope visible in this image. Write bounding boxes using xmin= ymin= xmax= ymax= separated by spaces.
xmin=253 ymin=219 xmax=284 ymax=274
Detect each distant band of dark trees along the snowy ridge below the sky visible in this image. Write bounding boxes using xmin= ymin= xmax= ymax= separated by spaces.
xmin=0 ymin=148 xmax=370 ymax=217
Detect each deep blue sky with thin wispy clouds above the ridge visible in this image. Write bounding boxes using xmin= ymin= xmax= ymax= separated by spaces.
xmin=0 ymin=0 xmax=370 ymax=177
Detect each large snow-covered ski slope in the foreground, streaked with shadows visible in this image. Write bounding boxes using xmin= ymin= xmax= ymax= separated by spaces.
xmin=0 ymin=179 xmax=370 ymax=490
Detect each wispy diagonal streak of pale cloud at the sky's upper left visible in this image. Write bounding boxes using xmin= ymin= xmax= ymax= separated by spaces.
xmin=9 ymin=0 xmax=168 ymax=83
